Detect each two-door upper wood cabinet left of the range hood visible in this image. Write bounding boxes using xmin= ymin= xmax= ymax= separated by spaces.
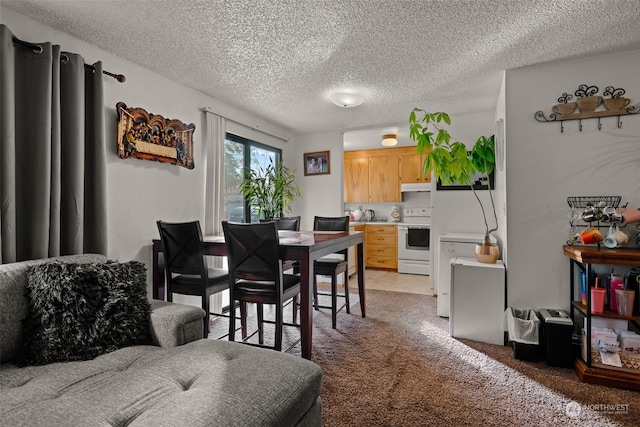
xmin=344 ymin=149 xmax=401 ymax=203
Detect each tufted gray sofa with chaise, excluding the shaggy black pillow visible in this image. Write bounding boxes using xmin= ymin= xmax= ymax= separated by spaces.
xmin=0 ymin=255 xmax=322 ymax=427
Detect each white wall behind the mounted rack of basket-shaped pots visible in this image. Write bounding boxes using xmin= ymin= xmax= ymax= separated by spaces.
xmin=505 ymin=50 xmax=640 ymax=309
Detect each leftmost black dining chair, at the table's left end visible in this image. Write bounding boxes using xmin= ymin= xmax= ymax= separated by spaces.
xmin=156 ymin=221 xmax=233 ymax=338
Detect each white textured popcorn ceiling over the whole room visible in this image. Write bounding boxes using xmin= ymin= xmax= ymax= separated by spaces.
xmin=0 ymin=0 xmax=640 ymax=149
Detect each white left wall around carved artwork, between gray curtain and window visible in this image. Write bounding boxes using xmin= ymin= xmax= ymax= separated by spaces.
xmin=0 ymin=8 xmax=296 ymax=296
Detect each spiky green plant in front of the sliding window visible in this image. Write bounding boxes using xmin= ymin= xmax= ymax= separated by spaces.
xmin=240 ymin=160 xmax=300 ymax=220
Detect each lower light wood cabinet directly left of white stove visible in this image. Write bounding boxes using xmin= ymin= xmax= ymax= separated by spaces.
xmin=365 ymin=224 xmax=398 ymax=270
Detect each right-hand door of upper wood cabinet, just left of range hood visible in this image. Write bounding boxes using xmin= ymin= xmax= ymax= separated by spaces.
xmin=369 ymin=155 xmax=400 ymax=202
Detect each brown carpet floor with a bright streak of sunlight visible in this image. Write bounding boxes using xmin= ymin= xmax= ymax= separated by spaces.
xmin=211 ymin=290 xmax=640 ymax=427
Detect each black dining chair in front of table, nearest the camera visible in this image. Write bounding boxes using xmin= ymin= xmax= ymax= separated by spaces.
xmin=222 ymin=221 xmax=300 ymax=351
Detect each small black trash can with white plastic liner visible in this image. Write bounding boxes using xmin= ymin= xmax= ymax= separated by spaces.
xmin=505 ymin=307 xmax=540 ymax=362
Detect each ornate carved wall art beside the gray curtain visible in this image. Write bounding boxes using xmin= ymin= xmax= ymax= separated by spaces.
xmin=116 ymin=102 xmax=196 ymax=169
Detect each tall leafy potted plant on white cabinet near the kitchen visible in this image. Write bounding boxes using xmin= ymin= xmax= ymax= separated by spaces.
xmin=409 ymin=108 xmax=499 ymax=263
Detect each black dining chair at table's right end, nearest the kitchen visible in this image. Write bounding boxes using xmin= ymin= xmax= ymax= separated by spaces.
xmin=313 ymin=216 xmax=351 ymax=329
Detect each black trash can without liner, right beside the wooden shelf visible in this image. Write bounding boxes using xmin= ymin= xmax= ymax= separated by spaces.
xmin=539 ymin=308 xmax=574 ymax=368
